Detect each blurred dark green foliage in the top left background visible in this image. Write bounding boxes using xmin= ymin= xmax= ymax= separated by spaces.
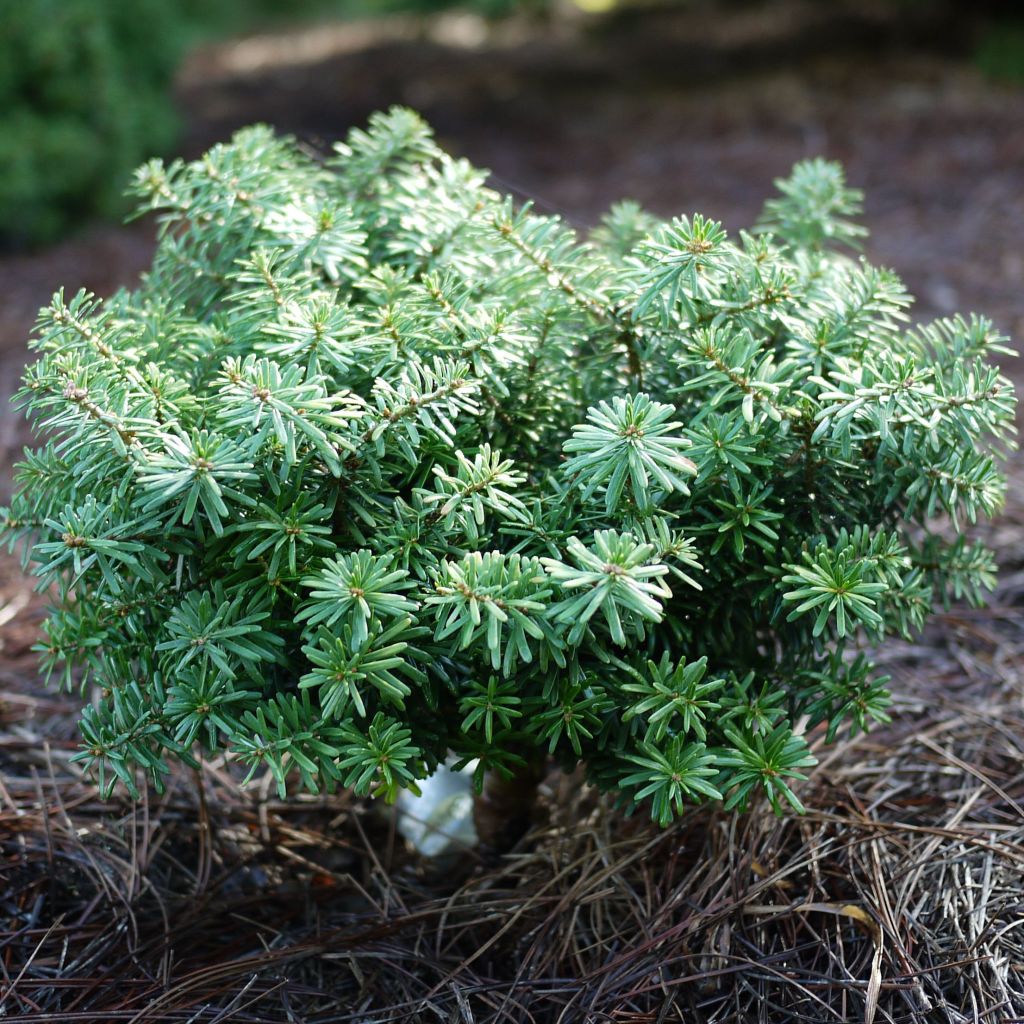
xmin=0 ymin=0 xmax=528 ymax=246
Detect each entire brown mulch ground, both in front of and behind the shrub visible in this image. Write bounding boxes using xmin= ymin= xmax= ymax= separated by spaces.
xmin=0 ymin=8 xmax=1024 ymax=1024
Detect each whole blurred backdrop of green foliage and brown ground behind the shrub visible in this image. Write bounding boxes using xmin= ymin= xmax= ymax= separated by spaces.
xmin=0 ymin=0 xmax=1024 ymax=346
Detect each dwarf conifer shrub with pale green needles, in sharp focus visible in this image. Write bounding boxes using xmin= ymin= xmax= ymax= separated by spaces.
xmin=5 ymin=110 xmax=1014 ymax=823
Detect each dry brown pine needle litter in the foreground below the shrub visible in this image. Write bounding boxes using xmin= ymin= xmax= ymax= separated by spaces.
xmin=0 ymin=495 xmax=1024 ymax=1024
